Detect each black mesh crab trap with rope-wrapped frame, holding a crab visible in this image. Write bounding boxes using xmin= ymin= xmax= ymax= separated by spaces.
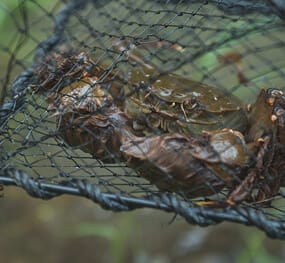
xmin=0 ymin=0 xmax=285 ymax=239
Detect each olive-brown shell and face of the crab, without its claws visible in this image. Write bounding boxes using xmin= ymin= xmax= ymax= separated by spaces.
xmin=125 ymin=65 xmax=247 ymax=135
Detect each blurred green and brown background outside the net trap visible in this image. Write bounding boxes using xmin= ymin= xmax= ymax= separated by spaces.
xmin=0 ymin=0 xmax=285 ymax=263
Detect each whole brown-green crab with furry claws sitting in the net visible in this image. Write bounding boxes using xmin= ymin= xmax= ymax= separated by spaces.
xmin=35 ymin=49 xmax=285 ymax=205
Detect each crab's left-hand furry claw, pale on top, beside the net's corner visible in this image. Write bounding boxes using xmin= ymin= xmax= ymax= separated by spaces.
xmin=43 ymin=73 xmax=136 ymax=163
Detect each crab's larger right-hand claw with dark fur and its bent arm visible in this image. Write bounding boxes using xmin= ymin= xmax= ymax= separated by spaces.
xmin=121 ymin=89 xmax=285 ymax=205
